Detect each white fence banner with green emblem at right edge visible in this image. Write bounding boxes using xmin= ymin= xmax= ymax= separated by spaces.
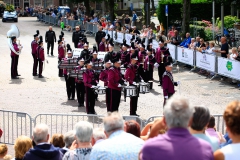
xmin=218 ymin=57 xmax=240 ymax=80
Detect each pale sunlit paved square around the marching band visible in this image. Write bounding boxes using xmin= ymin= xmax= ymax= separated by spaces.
xmin=0 ymin=17 xmax=240 ymax=155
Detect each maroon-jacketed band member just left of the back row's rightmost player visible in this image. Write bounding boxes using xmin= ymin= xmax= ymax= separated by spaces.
xmin=144 ymin=49 xmax=156 ymax=82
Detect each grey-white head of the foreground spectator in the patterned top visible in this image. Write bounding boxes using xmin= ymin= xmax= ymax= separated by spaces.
xmin=75 ymin=121 xmax=93 ymax=142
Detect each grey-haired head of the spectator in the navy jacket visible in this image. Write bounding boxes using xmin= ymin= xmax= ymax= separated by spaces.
xmin=33 ymin=123 xmax=48 ymax=144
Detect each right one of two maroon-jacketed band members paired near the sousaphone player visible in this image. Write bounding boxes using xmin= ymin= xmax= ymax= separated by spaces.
xmin=37 ymin=36 xmax=45 ymax=78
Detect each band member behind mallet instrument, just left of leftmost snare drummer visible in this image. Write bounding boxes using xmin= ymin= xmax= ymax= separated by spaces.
xmin=75 ymin=58 xmax=85 ymax=107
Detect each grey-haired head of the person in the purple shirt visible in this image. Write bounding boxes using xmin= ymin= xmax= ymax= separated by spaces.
xmin=164 ymin=95 xmax=193 ymax=128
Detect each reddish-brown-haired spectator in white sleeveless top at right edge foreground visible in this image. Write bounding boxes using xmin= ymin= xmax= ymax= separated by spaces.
xmin=214 ymin=101 xmax=240 ymax=160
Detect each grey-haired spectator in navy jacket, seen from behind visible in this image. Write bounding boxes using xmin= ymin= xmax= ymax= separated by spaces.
xmin=23 ymin=124 xmax=63 ymax=160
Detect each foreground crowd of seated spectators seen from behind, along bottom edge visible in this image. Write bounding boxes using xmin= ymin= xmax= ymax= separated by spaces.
xmin=0 ymin=95 xmax=240 ymax=160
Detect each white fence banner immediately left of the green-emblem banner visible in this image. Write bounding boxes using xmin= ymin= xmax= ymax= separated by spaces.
xmin=196 ymin=52 xmax=216 ymax=72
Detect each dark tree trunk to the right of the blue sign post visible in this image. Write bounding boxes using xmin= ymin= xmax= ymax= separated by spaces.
xmin=182 ymin=0 xmax=191 ymax=36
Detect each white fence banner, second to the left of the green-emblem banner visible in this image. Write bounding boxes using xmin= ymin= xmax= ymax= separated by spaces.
xmin=177 ymin=47 xmax=193 ymax=66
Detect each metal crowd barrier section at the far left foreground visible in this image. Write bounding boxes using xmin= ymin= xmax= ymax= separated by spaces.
xmin=0 ymin=110 xmax=32 ymax=144
